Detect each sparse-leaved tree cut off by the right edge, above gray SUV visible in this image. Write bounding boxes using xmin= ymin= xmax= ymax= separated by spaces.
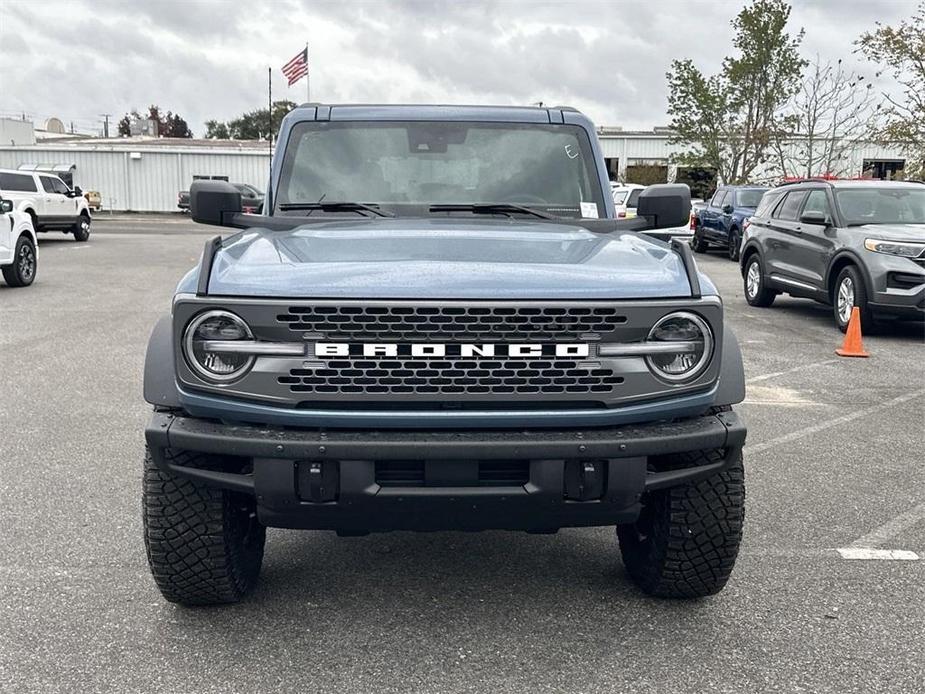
xmin=856 ymin=3 xmax=925 ymax=177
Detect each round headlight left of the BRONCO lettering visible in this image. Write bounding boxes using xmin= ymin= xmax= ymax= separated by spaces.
xmin=183 ymin=311 xmax=255 ymax=383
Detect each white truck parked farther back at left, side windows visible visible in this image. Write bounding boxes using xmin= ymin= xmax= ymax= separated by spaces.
xmin=0 ymin=169 xmax=90 ymax=241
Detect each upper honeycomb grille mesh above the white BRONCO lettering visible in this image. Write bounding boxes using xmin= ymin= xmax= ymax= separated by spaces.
xmin=276 ymin=305 xmax=627 ymax=342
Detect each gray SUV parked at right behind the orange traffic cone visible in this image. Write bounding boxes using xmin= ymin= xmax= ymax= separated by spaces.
xmin=741 ymin=180 xmax=925 ymax=331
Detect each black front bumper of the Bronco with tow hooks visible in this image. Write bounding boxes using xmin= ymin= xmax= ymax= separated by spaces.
xmin=145 ymin=412 xmax=746 ymax=534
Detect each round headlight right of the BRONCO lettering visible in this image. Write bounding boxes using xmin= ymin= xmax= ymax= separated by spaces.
xmin=646 ymin=311 xmax=713 ymax=383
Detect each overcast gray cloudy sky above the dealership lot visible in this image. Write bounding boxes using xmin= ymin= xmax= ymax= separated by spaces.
xmin=0 ymin=0 xmax=916 ymax=135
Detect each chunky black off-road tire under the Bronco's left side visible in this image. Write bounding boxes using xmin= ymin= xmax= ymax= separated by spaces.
xmin=142 ymin=450 xmax=266 ymax=605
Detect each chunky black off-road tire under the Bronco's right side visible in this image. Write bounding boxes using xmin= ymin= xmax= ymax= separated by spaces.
xmin=617 ymin=450 xmax=745 ymax=598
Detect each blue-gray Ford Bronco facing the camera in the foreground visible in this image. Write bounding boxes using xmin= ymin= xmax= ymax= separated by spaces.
xmin=143 ymin=104 xmax=745 ymax=605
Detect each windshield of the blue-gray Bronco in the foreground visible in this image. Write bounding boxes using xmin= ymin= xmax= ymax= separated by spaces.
xmin=276 ymin=121 xmax=606 ymax=217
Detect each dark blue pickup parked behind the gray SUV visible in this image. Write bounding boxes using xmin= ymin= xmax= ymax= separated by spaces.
xmin=691 ymin=186 xmax=767 ymax=260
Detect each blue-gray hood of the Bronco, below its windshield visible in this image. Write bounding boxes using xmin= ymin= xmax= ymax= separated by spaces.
xmin=189 ymin=218 xmax=715 ymax=299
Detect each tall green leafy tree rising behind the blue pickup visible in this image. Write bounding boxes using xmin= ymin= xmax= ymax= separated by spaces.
xmin=667 ymin=0 xmax=806 ymax=183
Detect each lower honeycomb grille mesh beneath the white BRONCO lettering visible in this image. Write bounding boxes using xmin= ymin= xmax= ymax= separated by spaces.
xmin=279 ymin=358 xmax=623 ymax=395
